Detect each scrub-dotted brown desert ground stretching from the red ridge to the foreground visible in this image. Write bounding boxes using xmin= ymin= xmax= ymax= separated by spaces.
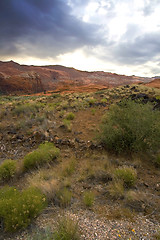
xmin=0 ymin=85 xmax=160 ymax=240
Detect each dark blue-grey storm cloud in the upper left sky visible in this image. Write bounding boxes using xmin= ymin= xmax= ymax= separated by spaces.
xmin=0 ymin=0 xmax=101 ymax=58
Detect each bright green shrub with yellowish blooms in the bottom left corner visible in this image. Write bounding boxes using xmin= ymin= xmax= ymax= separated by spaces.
xmin=0 ymin=186 xmax=46 ymax=232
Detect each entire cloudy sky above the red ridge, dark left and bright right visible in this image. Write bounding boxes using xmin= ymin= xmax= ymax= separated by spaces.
xmin=0 ymin=0 xmax=160 ymax=77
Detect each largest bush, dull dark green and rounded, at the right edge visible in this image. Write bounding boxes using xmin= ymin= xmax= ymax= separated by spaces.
xmin=99 ymin=100 xmax=160 ymax=153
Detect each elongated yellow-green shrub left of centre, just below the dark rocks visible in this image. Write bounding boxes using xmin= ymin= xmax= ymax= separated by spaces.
xmin=23 ymin=142 xmax=59 ymax=170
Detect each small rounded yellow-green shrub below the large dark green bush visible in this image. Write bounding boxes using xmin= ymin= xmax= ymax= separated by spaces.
xmin=114 ymin=166 xmax=137 ymax=188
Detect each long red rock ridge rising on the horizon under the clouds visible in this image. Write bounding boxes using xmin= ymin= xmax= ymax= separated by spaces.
xmin=0 ymin=61 xmax=151 ymax=93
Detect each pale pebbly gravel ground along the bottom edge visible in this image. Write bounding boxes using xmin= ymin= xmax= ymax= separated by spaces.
xmin=0 ymin=209 xmax=160 ymax=240
